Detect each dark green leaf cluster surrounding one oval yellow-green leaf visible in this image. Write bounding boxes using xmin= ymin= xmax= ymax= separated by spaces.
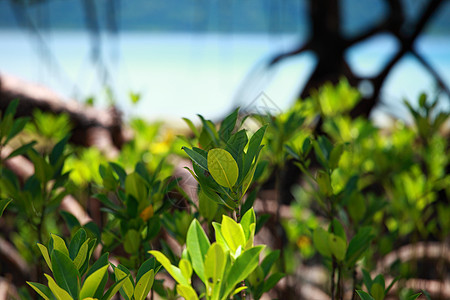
xmin=183 ymin=110 xmax=266 ymax=219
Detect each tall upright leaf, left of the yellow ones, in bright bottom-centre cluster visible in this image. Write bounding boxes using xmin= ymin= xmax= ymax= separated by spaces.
xmin=188 ymin=219 xmax=211 ymax=284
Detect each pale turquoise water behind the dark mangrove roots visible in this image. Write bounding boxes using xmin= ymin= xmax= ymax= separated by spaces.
xmin=0 ymin=31 xmax=450 ymax=120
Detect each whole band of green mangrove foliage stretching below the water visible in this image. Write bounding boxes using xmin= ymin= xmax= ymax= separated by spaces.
xmin=0 ymin=81 xmax=450 ymax=300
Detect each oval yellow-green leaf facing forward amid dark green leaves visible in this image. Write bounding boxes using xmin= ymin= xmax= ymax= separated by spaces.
xmin=207 ymin=148 xmax=239 ymax=189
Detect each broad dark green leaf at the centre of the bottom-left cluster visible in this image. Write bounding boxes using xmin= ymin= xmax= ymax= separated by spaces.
xmin=51 ymin=249 xmax=80 ymax=299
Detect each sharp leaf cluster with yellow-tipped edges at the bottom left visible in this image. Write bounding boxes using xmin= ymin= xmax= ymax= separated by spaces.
xmin=28 ymin=229 xmax=155 ymax=300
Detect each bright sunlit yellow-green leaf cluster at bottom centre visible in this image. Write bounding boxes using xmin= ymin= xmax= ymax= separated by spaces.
xmin=150 ymin=209 xmax=282 ymax=300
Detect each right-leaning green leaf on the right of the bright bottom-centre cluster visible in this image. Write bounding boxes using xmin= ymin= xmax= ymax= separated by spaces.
xmin=225 ymin=246 xmax=264 ymax=295
